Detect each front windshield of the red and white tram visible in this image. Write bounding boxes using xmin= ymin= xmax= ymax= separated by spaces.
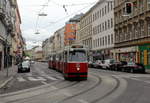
xmin=69 ymin=50 xmax=87 ymax=62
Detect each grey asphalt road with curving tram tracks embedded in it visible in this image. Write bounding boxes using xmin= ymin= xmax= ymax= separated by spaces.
xmin=0 ymin=63 xmax=150 ymax=103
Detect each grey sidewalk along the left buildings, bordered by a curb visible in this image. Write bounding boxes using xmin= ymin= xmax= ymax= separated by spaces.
xmin=0 ymin=65 xmax=17 ymax=88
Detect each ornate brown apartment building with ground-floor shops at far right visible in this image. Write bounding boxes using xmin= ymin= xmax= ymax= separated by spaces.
xmin=114 ymin=0 xmax=150 ymax=69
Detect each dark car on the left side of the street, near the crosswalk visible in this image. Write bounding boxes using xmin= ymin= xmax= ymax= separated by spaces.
xmin=18 ymin=60 xmax=30 ymax=73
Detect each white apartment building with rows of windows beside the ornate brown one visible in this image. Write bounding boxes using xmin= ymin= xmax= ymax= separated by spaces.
xmin=92 ymin=0 xmax=114 ymax=60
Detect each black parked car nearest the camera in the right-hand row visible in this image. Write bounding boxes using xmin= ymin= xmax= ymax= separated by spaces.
xmin=122 ymin=62 xmax=145 ymax=73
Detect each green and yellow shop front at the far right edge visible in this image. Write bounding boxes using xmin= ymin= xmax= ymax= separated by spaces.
xmin=139 ymin=44 xmax=150 ymax=69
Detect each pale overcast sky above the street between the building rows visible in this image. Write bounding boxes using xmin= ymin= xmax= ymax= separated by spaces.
xmin=18 ymin=0 xmax=98 ymax=49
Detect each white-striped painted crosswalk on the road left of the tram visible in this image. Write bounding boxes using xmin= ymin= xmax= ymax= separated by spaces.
xmin=16 ymin=75 xmax=63 ymax=82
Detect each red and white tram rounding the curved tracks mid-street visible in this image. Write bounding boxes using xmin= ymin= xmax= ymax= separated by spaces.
xmin=49 ymin=45 xmax=88 ymax=80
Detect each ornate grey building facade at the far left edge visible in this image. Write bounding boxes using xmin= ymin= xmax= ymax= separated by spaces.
xmin=0 ymin=0 xmax=18 ymax=69
